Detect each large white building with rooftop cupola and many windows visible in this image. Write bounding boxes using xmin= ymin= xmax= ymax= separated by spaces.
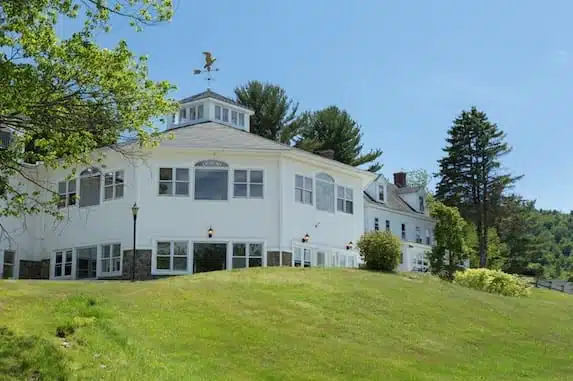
xmin=0 ymin=90 xmax=433 ymax=279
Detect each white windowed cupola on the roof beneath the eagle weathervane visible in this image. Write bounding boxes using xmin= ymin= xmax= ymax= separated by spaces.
xmin=167 ymin=90 xmax=254 ymax=132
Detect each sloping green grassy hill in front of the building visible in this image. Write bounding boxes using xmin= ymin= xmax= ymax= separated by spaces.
xmin=0 ymin=269 xmax=573 ymax=381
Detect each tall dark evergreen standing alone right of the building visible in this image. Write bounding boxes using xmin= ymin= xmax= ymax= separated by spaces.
xmin=436 ymin=107 xmax=520 ymax=267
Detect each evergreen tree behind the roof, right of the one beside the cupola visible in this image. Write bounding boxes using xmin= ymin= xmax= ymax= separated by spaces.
xmin=295 ymin=106 xmax=382 ymax=172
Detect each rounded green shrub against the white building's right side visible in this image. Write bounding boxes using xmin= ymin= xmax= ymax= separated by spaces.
xmin=358 ymin=231 xmax=401 ymax=271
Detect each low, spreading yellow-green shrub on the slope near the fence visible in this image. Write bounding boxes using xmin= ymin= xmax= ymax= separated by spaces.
xmin=454 ymin=269 xmax=530 ymax=296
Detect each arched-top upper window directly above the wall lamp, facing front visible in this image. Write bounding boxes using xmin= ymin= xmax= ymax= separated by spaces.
xmin=195 ymin=160 xmax=229 ymax=200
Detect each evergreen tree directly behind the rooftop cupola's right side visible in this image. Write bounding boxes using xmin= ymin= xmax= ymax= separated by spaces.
xmin=235 ymin=81 xmax=298 ymax=144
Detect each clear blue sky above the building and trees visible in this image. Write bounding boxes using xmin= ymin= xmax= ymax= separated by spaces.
xmin=68 ymin=0 xmax=573 ymax=211
